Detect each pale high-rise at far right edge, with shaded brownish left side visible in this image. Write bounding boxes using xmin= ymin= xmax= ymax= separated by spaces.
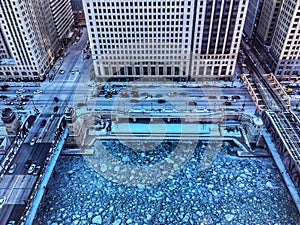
xmin=257 ymin=0 xmax=300 ymax=81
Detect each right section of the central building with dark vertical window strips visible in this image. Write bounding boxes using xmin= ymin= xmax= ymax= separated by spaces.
xmin=189 ymin=0 xmax=248 ymax=80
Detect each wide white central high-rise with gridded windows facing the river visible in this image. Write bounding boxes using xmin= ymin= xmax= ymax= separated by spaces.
xmin=83 ymin=0 xmax=248 ymax=80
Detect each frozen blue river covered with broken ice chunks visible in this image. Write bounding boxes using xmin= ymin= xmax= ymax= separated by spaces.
xmin=34 ymin=141 xmax=300 ymax=225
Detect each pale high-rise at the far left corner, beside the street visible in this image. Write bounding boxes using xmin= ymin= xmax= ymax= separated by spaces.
xmin=0 ymin=0 xmax=74 ymax=80
